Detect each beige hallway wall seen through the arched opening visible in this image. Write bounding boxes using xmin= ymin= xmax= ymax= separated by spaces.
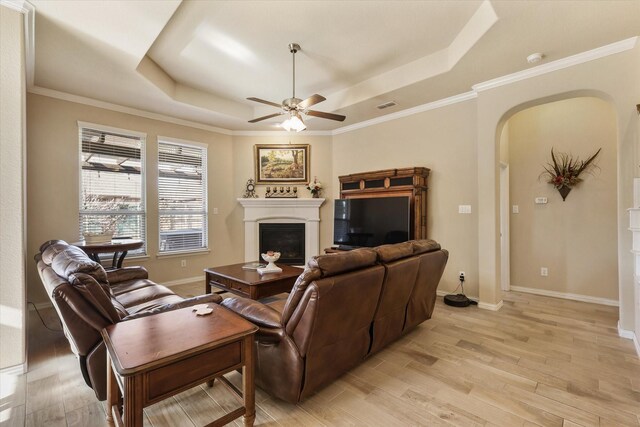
xmin=507 ymin=98 xmax=618 ymax=301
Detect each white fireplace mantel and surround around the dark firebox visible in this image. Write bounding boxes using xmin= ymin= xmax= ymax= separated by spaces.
xmin=238 ymin=198 xmax=324 ymax=263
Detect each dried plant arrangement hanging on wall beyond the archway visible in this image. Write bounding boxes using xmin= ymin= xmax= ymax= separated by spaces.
xmin=540 ymin=148 xmax=602 ymax=202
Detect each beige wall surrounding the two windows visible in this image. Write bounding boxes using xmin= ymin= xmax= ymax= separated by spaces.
xmin=27 ymin=94 xmax=243 ymax=302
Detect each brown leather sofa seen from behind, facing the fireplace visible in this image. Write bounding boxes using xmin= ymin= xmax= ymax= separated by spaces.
xmin=221 ymin=240 xmax=449 ymax=402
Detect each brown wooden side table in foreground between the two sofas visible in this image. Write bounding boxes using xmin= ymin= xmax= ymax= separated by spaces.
xmin=102 ymin=304 xmax=258 ymax=427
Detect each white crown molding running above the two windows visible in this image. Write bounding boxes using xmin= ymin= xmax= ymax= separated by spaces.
xmin=27 ymin=86 xmax=232 ymax=135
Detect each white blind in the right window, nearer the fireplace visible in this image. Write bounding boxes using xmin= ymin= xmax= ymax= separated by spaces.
xmin=158 ymin=140 xmax=208 ymax=253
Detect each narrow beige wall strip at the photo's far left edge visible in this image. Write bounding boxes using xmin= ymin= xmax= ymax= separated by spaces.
xmin=0 ymin=6 xmax=26 ymax=369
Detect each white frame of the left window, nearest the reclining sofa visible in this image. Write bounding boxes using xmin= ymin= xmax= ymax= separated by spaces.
xmin=77 ymin=120 xmax=149 ymax=259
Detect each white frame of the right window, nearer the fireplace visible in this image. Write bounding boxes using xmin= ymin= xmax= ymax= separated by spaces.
xmin=156 ymin=135 xmax=211 ymax=257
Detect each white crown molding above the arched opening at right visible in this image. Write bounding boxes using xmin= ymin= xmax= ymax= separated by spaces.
xmin=471 ymin=36 xmax=638 ymax=92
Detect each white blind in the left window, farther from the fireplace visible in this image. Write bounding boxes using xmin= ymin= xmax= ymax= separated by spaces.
xmin=79 ymin=125 xmax=146 ymax=254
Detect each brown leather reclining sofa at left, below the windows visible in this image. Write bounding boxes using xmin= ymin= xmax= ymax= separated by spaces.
xmin=35 ymin=240 xmax=222 ymax=400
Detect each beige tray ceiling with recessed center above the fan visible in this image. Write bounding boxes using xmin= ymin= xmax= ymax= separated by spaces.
xmin=26 ymin=0 xmax=640 ymax=130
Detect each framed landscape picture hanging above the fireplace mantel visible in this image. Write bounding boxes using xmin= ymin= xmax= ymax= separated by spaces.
xmin=254 ymin=144 xmax=310 ymax=184
